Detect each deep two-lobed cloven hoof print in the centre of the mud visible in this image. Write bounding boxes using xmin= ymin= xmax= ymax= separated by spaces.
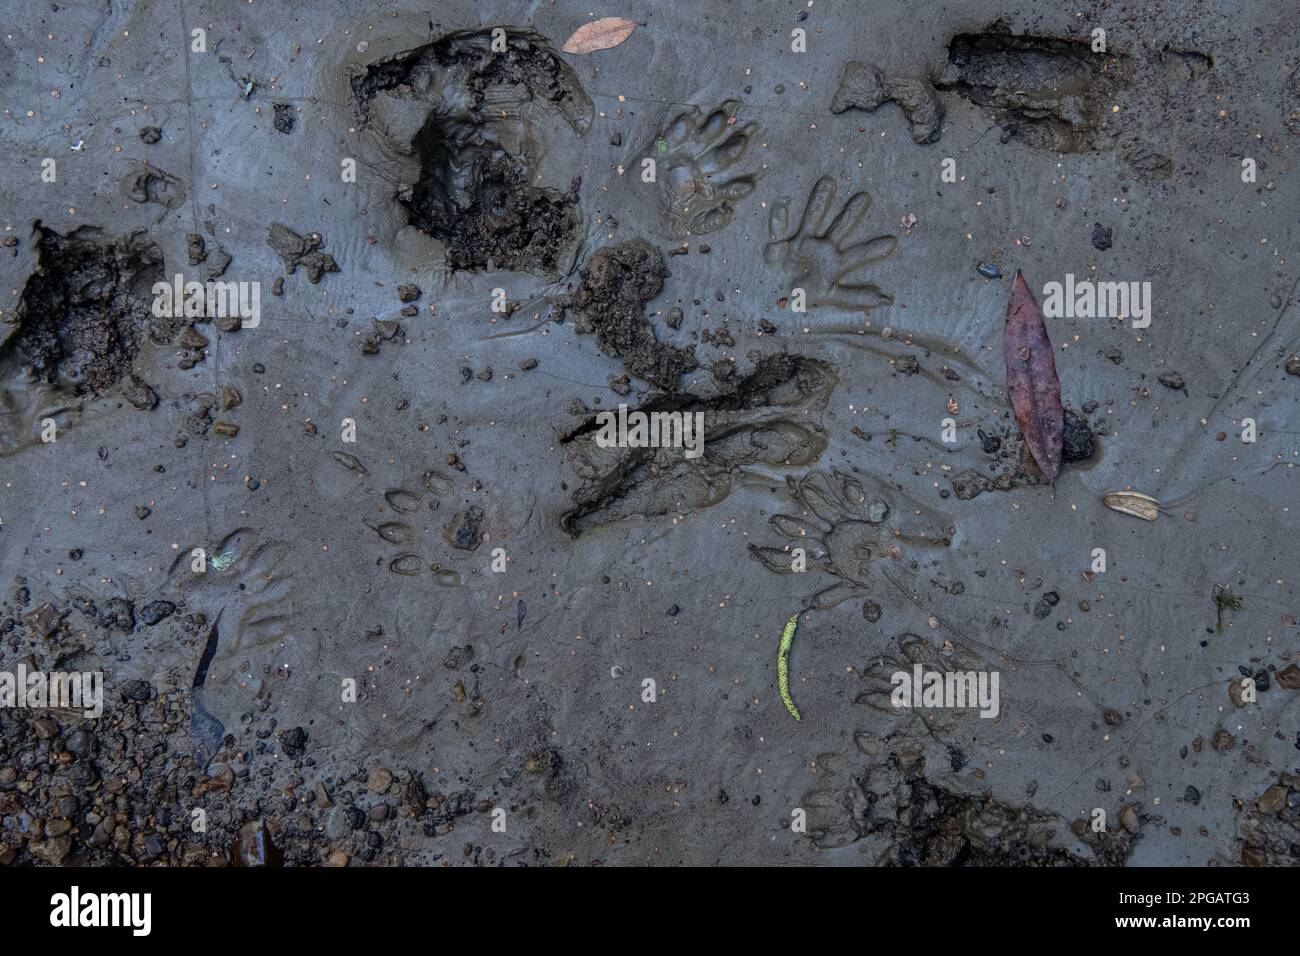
xmin=560 ymin=355 xmax=839 ymax=537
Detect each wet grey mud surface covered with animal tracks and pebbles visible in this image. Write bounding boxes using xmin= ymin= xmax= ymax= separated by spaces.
xmin=0 ymin=0 xmax=1300 ymax=866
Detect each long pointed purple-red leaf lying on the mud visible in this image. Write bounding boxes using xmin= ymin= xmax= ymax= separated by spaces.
xmin=1002 ymin=272 xmax=1065 ymax=481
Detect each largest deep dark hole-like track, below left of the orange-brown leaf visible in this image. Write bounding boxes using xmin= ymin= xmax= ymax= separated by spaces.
xmin=351 ymin=27 xmax=593 ymax=276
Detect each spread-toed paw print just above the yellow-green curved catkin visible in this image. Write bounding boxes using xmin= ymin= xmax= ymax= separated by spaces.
xmin=749 ymin=468 xmax=957 ymax=609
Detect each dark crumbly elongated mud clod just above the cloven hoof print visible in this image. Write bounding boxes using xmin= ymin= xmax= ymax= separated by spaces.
xmin=564 ymin=239 xmax=697 ymax=390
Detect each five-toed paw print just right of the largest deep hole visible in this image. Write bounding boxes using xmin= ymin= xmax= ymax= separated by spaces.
xmin=650 ymin=100 xmax=762 ymax=238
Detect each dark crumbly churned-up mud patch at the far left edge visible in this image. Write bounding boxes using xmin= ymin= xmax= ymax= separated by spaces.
xmin=0 ymin=222 xmax=165 ymax=395
